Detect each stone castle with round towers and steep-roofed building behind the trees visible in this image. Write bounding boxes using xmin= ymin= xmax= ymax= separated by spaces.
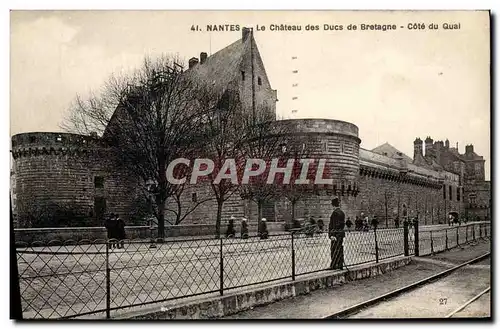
xmin=12 ymin=28 xmax=491 ymax=227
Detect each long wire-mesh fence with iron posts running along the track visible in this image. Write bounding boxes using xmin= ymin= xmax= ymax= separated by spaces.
xmin=16 ymin=223 xmax=491 ymax=319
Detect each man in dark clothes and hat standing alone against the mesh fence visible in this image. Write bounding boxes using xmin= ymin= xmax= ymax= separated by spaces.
xmin=328 ymin=197 xmax=345 ymax=270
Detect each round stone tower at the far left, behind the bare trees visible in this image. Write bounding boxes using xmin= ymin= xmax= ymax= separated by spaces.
xmin=12 ymin=132 xmax=100 ymax=227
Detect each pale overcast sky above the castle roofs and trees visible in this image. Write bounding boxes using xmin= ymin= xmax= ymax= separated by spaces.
xmin=10 ymin=11 xmax=490 ymax=179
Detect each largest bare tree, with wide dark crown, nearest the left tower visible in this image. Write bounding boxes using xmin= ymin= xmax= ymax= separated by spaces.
xmin=63 ymin=56 xmax=210 ymax=238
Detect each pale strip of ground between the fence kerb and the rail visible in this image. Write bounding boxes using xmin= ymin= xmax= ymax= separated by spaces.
xmin=224 ymin=241 xmax=490 ymax=319
